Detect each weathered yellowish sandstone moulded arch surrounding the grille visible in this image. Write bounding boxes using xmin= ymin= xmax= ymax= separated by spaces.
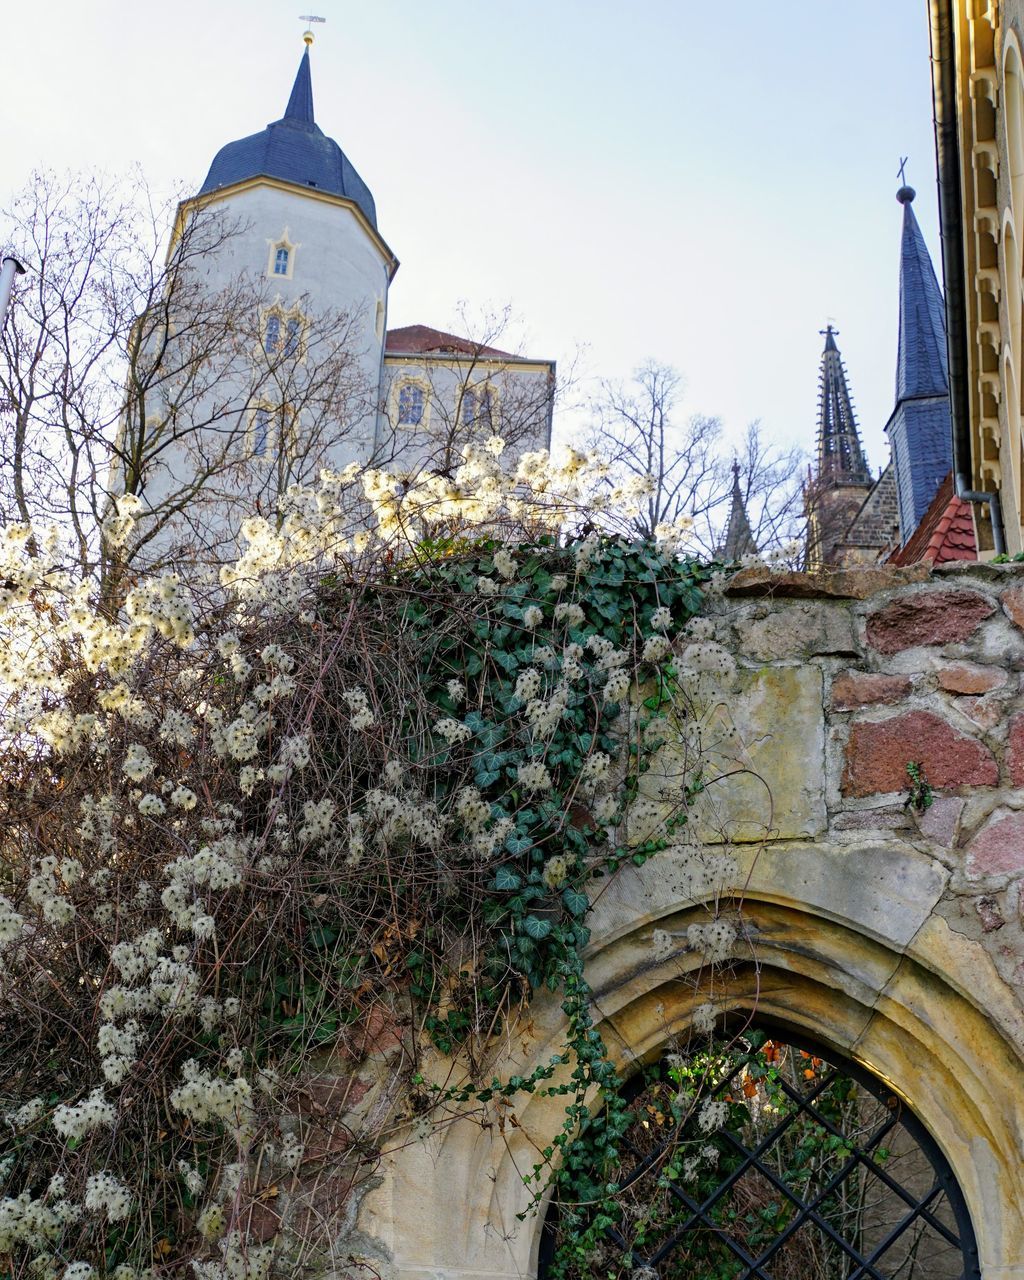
xmin=365 ymin=846 xmax=1024 ymax=1280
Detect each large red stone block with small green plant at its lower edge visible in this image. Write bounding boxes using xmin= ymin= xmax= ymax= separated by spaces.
xmin=842 ymin=712 xmax=998 ymax=796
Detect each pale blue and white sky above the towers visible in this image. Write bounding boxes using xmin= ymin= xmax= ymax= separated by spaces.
xmin=0 ymin=0 xmax=941 ymax=468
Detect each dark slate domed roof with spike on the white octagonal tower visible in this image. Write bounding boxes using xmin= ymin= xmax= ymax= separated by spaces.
xmin=198 ymin=37 xmax=376 ymax=230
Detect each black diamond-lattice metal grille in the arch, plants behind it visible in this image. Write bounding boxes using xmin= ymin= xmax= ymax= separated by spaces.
xmin=540 ymin=1032 xmax=980 ymax=1280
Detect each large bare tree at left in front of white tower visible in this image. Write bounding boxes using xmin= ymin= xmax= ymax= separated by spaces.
xmin=0 ymin=174 xmax=372 ymax=588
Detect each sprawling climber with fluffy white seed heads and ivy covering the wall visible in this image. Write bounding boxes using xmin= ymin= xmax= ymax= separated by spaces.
xmin=0 ymin=439 xmax=730 ymax=1280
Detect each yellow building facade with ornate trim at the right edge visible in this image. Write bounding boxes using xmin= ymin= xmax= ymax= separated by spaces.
xmin=928 ymin=0 xmax=1024 ymax=557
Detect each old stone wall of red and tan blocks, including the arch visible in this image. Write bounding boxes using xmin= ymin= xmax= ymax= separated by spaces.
xmin=271 ymin=566 xmax=1024 ymax=1280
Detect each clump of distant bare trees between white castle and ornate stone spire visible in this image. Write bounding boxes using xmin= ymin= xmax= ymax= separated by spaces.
xmin=588 ymin=360 xmax=804 ymax=554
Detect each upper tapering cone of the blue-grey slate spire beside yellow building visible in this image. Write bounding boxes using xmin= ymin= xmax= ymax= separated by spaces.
xmin=896 ymin=187 xmax=950 ymax=402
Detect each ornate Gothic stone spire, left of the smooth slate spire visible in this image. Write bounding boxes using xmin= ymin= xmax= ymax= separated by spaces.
xmin=804 ymin=324 xmax=873 ymax=568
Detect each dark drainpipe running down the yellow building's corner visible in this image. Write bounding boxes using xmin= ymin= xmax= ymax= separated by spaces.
xmin=929 ymin=0 xmax=1006 ymax=556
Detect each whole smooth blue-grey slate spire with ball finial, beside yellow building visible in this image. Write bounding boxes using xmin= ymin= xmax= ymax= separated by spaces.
xmin=886 ymin=186 xmax=952 ymax=544
